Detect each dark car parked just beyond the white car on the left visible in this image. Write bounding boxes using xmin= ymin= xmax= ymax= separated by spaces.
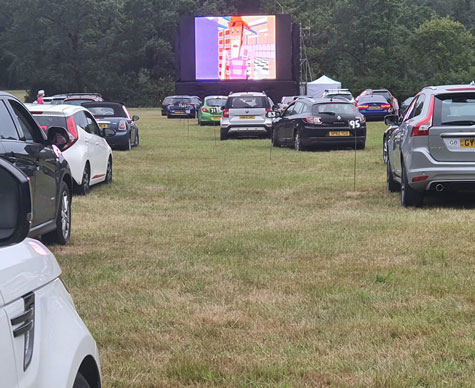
xmin=82 ymin=101 xmax=139 ymax=150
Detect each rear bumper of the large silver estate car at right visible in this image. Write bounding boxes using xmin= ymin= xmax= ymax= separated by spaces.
xmin=404 ymin=148 xmax=475 ymax=191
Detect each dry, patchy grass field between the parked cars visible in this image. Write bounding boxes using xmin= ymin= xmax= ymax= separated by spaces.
xmin=52 ymin=109 xmax=475 ymax=388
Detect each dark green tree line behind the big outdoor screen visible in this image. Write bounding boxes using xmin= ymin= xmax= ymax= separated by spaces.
xmin=0 ymin=0 xmax=475 ymax=106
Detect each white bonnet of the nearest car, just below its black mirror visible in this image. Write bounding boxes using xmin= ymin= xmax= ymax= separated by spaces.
xmin=0 ymin=238 xmax=61 ymax=307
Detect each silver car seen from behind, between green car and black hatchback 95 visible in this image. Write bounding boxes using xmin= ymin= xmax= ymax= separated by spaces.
xmin=221 ymin=92 xmax=272 ymax=140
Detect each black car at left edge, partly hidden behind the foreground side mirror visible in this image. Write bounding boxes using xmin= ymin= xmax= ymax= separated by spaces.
xmin=0 ymin=92 xmax=73 ymax=244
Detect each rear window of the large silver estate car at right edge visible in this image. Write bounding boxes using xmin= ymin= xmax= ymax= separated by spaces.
xmin=434 ymin=92 xmax=475 ymax=126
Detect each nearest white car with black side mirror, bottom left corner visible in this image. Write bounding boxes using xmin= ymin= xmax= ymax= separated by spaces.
xmin=0 ymin=159 xmax=101 ymax=388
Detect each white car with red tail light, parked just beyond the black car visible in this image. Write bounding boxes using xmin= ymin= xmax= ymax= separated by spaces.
xmin=26 ymin=104 xmax=112 ymax=195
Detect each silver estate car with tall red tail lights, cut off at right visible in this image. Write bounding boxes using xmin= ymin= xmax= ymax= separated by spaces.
xmin=385 ymin=82 xmax=475 ymax=206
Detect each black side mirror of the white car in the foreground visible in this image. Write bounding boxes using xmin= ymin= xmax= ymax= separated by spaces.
xmin=0 ymin=158 xmax=32 ymax=247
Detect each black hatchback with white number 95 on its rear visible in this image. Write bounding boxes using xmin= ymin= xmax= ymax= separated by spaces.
xmin=268 ymin=98 xmax=366 ymax=151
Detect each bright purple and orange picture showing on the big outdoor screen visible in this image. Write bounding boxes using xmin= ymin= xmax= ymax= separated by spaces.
xmin=195 ymin=16 xmax=277 ymax=81
